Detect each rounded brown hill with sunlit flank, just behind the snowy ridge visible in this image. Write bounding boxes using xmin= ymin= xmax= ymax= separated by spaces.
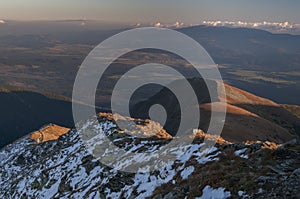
xmin=131 ymin=79 xmax=300 ymax=143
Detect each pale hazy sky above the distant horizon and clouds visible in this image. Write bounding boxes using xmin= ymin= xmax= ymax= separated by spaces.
xmin=0 ymin=0 xmax=300 ymax=24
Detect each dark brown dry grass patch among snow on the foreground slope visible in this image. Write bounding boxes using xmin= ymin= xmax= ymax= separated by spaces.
xmin=154 ymin=143 xmax=282 ymax=198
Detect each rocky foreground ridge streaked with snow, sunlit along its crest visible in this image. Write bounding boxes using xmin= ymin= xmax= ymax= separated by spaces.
xmin=0 ymin=114 xmax=300 ymax=199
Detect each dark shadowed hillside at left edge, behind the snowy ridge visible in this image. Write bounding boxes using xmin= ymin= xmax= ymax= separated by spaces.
xmin=0 ymin=87 xmax=103 ymax=148
